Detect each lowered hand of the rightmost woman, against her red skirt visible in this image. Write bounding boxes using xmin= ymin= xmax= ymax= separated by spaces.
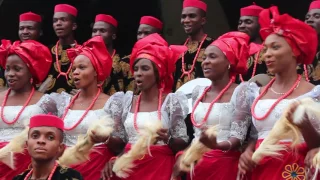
xmin=238 ymin=149 xmax=256 ymax=175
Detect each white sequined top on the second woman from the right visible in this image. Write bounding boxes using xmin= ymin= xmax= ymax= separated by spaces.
xmin=192 ymin=85 xmax=251 ymax=143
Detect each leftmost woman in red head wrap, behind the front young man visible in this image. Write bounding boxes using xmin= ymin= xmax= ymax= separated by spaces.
xmin=0 ymin=40 xmax=57 ymax=179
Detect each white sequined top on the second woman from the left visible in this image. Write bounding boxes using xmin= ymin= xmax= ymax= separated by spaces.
xmin=50 ymin=92 xmax=125 ymax=146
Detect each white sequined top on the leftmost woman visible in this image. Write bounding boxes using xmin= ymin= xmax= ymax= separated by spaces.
xmin=0 ymin=95 xmax=57 ymax=142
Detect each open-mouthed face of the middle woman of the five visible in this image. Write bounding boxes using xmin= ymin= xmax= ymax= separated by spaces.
xmin=133 ymin=59 xmax=157 ymax=91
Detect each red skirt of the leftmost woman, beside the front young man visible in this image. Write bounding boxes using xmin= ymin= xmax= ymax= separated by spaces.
xmin=0 ymin=142 xmax=31 ymax=180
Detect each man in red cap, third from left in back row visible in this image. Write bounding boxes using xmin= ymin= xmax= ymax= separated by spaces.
xmin=92 ymin=14 xmax=124 ymax=95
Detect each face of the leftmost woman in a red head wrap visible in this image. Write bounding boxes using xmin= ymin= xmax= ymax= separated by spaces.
xmin=4 ymin=54 xmax=32 ymax=91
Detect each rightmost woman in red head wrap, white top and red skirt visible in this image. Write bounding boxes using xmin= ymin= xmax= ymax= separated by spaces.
xmin=236 ymin=6 xmax=320 ymax=180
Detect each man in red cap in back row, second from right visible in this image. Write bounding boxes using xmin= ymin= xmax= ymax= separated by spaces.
xmin=237 ymin=4 xmax=267 ymax=83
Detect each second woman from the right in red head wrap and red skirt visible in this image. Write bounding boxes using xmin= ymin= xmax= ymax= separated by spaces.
xmin=171 ymin=32 xmax=250 ymax=180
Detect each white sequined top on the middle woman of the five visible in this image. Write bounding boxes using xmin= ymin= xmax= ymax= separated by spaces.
xmin=122 ymin=91 xmax=189 ymax=145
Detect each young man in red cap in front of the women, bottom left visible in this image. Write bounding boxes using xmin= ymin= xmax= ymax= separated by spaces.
xmin=14 ymin=115 xmax=83 ymax=180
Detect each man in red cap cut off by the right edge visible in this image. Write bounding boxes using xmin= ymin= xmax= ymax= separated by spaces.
xmin=304 ymin=0 xmax=320 ymax=85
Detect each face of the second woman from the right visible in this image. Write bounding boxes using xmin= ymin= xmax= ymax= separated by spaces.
xmin=201 ymin=46 xmax=230 ymax=80
